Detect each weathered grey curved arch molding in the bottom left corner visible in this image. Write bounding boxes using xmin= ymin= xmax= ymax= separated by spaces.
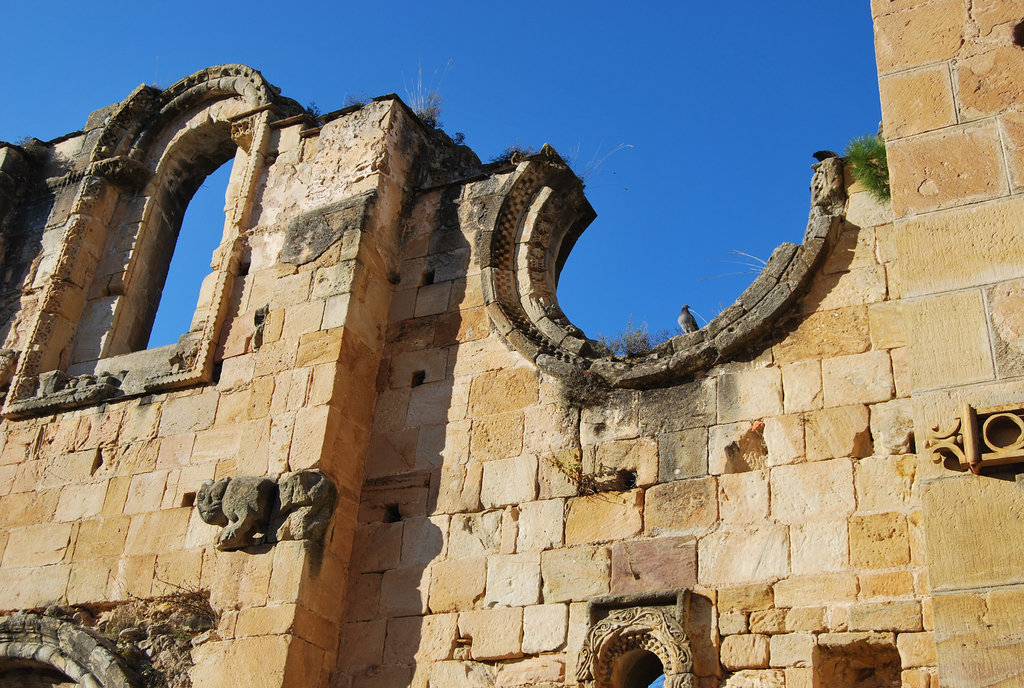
xmin=0 ymin=613 xmax=140 ymax=688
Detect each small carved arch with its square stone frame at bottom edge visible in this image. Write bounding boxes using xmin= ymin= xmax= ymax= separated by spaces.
xmin=577 ymin=591 xmax=694 ymax=688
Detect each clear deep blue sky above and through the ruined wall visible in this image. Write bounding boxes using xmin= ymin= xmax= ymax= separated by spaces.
xmin=0 ymin=0 xmax=881 ymax=350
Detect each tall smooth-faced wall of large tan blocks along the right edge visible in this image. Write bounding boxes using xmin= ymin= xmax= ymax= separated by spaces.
xmin=871 ymin=0 xmax=1024 ymax=686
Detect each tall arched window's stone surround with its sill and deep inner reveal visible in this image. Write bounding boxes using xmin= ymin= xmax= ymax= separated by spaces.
xmin=3 ymin=65 xmax=302 ymax=417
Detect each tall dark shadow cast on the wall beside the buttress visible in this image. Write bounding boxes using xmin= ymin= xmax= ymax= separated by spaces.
xmin=336 ymin=186 xmax=468 ymax=686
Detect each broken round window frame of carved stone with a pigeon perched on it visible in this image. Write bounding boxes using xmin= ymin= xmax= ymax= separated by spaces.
xmin=479 ymin=151 xmax=846 ymax=388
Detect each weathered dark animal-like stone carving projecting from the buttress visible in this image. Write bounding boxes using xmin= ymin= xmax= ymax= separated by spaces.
xmin=196 ymin=471 xmax=337 ymax=551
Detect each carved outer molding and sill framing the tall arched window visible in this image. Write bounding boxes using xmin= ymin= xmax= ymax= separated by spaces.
xmin=3 ymin=65 xmax=302 ymax=417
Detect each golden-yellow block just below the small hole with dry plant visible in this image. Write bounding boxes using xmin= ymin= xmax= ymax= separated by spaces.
xmin=565 ymin=491 xmax=638 ymax=545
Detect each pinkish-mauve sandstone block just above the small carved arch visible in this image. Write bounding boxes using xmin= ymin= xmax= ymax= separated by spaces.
xmin=611 ymin=538 xmax=697 ymax=595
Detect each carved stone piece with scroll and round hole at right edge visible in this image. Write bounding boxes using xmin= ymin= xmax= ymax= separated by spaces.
xmin=928 ymin=404 xmax=1024 ymax=473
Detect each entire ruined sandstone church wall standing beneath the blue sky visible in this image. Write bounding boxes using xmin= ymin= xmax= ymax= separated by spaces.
xmin=0 ymin=0 xmax=1024 ymax=688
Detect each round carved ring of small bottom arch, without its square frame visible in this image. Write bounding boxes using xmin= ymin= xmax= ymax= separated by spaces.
xmin=577 ymin=607 xmax=693 ymax=688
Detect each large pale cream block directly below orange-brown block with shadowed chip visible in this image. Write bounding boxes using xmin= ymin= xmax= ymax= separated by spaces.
xmin=771 ymin=456 xmax=851 ymax=523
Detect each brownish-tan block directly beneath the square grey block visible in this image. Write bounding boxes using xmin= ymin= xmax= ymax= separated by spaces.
xmin=643 ymin=477 xmax=718 ymax=541
